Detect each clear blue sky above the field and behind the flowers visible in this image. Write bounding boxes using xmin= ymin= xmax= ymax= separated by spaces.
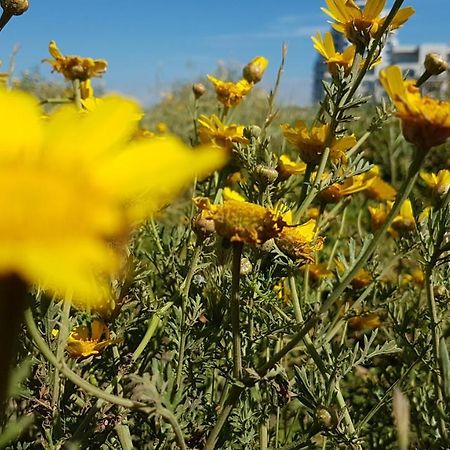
xmin=0 ymin=0 xmax=450 ymax=104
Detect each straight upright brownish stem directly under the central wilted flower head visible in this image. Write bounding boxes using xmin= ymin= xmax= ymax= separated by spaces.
xmin=230 ymin=242 xmax=243 ymax=380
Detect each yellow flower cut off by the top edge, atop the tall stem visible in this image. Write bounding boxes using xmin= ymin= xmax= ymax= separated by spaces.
xmin=321 ymin=0 xmax=414 ymax=45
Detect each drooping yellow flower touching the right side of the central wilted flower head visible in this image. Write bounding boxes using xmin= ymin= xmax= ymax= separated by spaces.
xmin=275 ymin=211 xmax=323 ymax=265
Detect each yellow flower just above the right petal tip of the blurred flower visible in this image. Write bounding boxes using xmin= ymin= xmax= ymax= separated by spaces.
xmin=197 ymin=114 xmax=248 ymax=151
